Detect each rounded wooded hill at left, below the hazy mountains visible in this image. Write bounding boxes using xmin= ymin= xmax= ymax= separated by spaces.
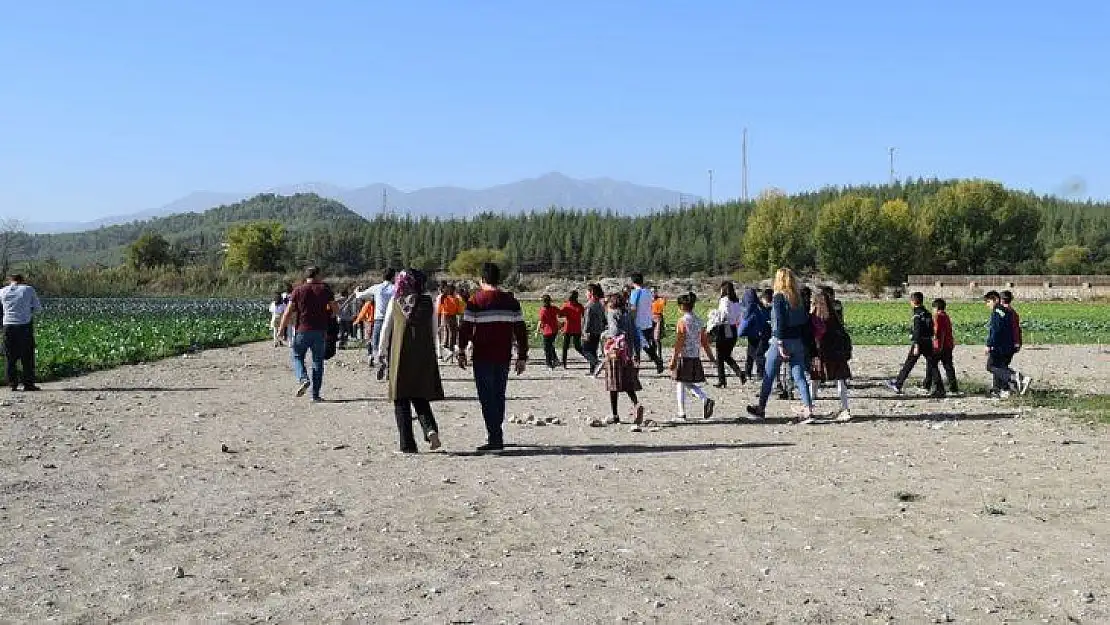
xmin=29 ymin=193 xmax=365 ymax=265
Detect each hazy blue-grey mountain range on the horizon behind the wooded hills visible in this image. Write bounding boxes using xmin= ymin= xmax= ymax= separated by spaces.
xmin=27 ymin=172 xmax=699 ymax=233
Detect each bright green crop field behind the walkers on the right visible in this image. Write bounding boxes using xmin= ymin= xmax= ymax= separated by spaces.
xmin=515 ymin=302 xmax=1110 ymax=345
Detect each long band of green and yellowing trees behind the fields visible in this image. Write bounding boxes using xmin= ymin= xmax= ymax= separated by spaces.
xmin=21 ymin=180 xmax=1110 ymax=281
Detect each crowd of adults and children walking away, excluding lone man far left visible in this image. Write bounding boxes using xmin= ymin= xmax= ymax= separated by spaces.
xmin=275 ymin=264 xmax=1031 ymax=453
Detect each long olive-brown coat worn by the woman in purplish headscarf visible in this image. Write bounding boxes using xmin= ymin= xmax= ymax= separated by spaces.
xmin=383 ymin=295 xmax=443 ymax=402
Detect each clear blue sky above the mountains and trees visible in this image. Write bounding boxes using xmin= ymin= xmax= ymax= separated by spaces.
xmin=0 ymin=0 xmax=1110 ymax=221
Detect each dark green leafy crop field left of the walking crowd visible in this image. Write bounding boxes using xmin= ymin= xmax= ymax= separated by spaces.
xmin=20 ymin=298 xmax=270 ymax=381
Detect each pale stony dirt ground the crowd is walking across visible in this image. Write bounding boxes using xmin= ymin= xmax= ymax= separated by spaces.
xmin=0 ymin=344 xmax=1110 ymax=624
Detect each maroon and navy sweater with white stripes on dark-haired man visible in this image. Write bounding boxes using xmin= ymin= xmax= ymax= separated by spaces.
xmin=458 ymin=289 xmax=528 ymax=364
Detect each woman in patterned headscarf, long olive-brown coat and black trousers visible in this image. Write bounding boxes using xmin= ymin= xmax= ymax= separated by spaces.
xmin=377 ymin=269 xmax=443 ymax=454
